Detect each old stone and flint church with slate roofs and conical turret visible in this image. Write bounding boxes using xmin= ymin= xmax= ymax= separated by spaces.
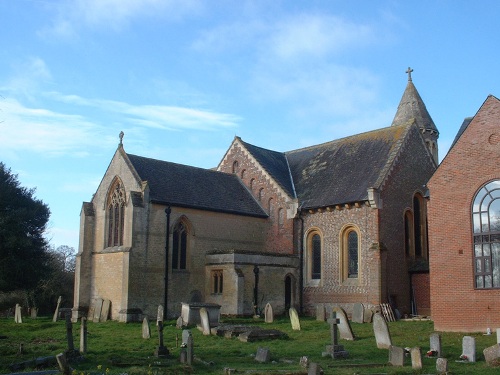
xmin=73 ymin=69 xmax=440 ymax=322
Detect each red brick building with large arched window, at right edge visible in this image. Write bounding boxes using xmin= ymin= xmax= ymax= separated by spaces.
xmin=428 ymin=96 xmax=500 ymax=332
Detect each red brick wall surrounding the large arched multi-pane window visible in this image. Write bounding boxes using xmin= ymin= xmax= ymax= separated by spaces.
xmin=428 ymin=96 xmax=500 ymax=332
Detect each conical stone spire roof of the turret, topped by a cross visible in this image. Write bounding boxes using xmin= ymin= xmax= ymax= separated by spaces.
xmin=392 ymin=75 xmax=439 ymax=134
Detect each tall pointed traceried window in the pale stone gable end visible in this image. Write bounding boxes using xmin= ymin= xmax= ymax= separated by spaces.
xmin=106 ymin=178 xmax=125 ymax=247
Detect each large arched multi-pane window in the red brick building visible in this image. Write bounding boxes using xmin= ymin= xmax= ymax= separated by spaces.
xmin=472 ymin=180 xmax=500 ymax=289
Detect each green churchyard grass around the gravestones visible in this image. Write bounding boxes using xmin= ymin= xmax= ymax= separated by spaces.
xmin=0 ymin=317 xmax=500 ymax=375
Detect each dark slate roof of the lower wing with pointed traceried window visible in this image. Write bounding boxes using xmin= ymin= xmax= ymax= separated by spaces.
xmin=127 ymin=154 xmax=268 ymax=217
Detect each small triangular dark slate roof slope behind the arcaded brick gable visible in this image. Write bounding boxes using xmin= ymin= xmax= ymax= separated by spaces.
xmin=239 ymin=138 xmax=295 ymax=198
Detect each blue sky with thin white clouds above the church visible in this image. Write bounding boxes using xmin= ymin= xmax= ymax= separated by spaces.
xmin=0 ymin=0 xmax=500 ymax=253
